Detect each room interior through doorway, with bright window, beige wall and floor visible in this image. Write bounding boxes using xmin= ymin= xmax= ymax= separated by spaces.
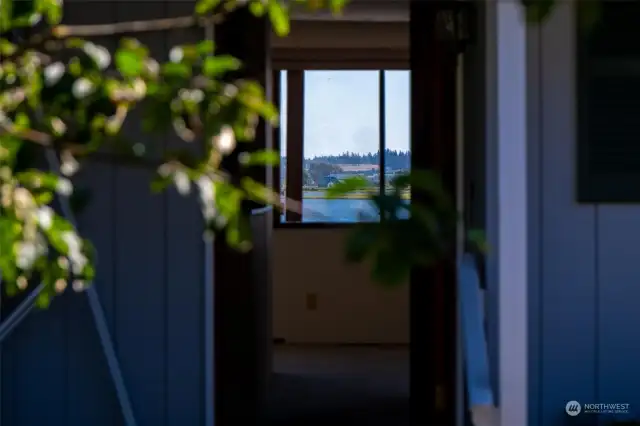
xmin=269 ymin=60 xmax=411 ymax=425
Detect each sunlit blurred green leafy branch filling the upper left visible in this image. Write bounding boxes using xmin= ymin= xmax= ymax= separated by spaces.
xmin=0 ymin=0 xmax=344 ymax=304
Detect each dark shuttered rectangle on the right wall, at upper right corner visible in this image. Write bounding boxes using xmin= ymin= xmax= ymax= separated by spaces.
xmin=577 ymin=2 xmax=640 ymax=202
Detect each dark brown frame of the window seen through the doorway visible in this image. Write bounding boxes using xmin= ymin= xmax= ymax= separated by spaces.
xmin=271 ymin=52 xmax=411 ymax=229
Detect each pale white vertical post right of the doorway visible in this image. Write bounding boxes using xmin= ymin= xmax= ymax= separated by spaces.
xmin=485 ymin=1 xmax=529 ymax=426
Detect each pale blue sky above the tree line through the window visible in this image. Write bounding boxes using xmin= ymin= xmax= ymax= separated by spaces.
xmin=280 ymin=70 xmax=410 ymax=158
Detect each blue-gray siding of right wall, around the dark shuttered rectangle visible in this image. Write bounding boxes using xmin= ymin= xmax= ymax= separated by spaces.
xmin=529 ymin=2 xmax=640 ymax=426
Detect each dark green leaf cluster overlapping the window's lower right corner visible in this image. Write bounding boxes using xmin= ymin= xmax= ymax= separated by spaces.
xmin=327 ymin=170 xmax=487 ymax=286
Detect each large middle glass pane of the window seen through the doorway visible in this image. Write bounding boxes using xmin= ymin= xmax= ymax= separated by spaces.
xmin=302 ymin=71 xmax=380 ymax=222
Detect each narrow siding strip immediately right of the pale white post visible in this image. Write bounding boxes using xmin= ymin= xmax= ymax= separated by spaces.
xmin=527 ymin=17 xmax=542 ymax=425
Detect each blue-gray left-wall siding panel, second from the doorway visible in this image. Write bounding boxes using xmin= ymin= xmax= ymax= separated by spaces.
xmin=115 ymin=2 xmax=167 ymax=426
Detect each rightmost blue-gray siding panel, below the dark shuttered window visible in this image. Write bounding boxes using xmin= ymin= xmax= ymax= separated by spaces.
xmin=597 ymin=205 xmax=640 ymax=418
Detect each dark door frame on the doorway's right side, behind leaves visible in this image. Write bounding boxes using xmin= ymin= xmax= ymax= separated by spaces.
xmin=410 ymin=0 xmax=458 ymax=425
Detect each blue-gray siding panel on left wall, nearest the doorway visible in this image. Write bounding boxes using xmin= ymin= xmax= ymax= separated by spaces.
xmin=165 ymin=1 xmax=204 ymax=426
